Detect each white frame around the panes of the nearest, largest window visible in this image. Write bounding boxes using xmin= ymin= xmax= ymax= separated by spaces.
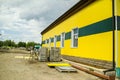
xmin=71 ymin=28 xmax=78 ymax=48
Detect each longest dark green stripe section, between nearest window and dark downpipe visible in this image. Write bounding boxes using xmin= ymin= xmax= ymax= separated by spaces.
xmin=79 ymin=18 xmax=113 ymax=37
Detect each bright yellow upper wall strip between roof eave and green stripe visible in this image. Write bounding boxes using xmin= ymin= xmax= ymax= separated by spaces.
xmin=43 ymin=0 xmax=112 ymax=40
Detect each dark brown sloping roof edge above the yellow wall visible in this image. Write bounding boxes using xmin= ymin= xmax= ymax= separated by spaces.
xmin=41 ymin=0 xmax=95 ymax=34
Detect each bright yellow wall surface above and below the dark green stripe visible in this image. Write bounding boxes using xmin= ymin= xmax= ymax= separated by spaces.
xmin=43 ymin=0 xmax=112 ymax=61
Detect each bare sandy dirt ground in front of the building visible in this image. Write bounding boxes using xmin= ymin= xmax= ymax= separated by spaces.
xmin=0 ymin=52 xmax=101 ymax=80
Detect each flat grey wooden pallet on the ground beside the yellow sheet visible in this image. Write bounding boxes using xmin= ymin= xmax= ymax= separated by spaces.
xmin=55 ymin=66 xmax=77 ymax=73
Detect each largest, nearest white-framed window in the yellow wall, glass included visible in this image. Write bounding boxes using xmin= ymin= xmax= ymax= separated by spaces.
xmin=71 ymin=28 xmax=78 ymax=47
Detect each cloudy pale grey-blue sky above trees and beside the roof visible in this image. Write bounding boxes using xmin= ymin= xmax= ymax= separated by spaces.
xmin=0 ymin=0 xmax=79 ymax=43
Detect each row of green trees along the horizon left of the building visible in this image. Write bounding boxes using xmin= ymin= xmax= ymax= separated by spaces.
xmin=0 ymin=40 xmax=40 ymax=48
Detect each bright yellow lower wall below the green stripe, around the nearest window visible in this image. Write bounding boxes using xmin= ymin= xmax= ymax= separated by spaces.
xmin=62 ymin=31 xmax=113 ymax=61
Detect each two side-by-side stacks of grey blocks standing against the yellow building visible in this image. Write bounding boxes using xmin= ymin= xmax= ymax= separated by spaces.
xmin=38 ymin=47 xmax=61 ymax=62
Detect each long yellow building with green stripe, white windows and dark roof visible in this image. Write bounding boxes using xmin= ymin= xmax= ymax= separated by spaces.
xmin=41 ymin=0 xmax=120 ymax=76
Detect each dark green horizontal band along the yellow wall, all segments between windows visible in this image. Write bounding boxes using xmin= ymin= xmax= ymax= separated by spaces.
xmin=44 ymin=16 xmax=115 ymax=43
